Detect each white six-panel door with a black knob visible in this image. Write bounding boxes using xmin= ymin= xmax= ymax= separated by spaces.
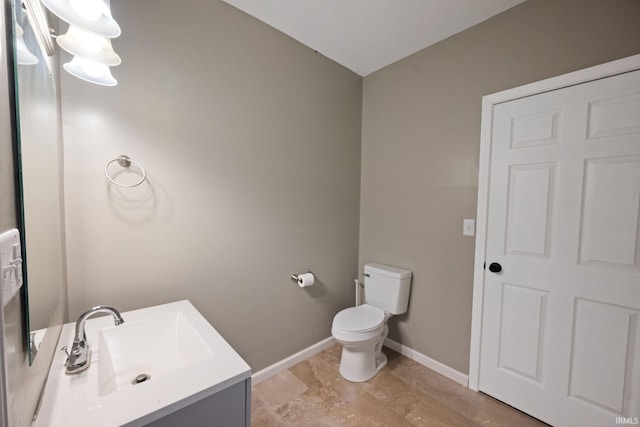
xmin=479 ymin=71 xmax=640 ymax=426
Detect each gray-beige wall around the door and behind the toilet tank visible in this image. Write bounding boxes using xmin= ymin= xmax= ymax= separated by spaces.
xmin=359 ymin=0 xmax=640 ymax=373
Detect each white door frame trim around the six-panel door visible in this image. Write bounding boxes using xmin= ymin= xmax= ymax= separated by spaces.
xmin=469 ymin=54 xmax=640 ymax=391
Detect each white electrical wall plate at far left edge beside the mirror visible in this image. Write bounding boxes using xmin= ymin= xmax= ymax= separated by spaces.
xmin=0 ymin=228 xmax=22 ymax=307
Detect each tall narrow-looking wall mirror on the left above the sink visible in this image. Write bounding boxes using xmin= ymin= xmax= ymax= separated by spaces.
xmin=12 ymin=0 xmax=66 ymax=364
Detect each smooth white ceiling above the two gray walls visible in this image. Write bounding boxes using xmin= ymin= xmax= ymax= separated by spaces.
xmin=224 ymin=0 xmax=524 ymax=76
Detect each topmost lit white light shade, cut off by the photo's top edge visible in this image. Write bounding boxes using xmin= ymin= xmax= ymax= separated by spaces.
xmin=42 ymin=0 xmax=120 ymax=38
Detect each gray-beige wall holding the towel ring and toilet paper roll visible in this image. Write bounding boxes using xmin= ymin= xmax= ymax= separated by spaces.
xmin=62 ymin=0 xmax=362 ymax=371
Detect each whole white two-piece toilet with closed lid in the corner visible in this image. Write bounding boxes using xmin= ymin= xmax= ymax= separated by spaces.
xmin=331 ymin=263 xmax=411 ymax=382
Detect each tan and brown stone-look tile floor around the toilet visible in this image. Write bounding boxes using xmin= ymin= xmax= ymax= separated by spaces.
xmin=251 ymin=344 xmax=546 ymax=427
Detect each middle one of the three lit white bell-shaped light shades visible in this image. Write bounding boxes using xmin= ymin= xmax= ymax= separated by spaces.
xmin=56 ymin=25 xmax=121 ymax=66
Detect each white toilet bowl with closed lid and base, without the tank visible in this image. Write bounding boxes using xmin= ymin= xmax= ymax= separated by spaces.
xmin=331 ymin=304 xmax=391 ymax=382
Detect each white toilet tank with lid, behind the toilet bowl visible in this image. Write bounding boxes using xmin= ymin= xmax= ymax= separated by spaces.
xmin=364 ymin=263 xmax=412 ymax=314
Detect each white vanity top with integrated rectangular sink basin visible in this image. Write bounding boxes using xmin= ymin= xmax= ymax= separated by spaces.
xmin=34 ymin=301 xmax=251 ymax=427
